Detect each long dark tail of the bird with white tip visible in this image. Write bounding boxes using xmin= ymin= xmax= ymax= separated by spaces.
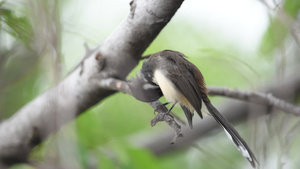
xmin=203 ymin=97 xmax=257 ymax=168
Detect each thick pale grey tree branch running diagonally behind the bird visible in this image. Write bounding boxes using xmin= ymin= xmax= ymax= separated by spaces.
xmin=0 ymin=0 xmax=183 ymax=167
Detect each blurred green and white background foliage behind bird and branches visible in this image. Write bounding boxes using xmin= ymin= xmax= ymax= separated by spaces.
xmin=0 ymin=0 xmax=300 ymax=169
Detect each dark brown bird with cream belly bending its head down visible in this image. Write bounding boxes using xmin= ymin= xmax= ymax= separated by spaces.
xmin=128 ymin=50 xmax=258 ymax=168
